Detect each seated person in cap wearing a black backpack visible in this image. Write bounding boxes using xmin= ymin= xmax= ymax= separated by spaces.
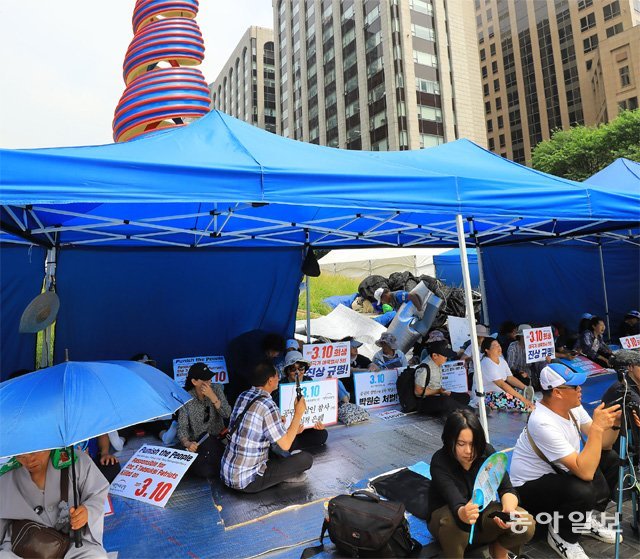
xmin=414 ymin=340 xmax=469 ymax=415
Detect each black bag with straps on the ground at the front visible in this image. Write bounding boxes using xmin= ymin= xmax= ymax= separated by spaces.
xmin=301 ymin=491 xmax=422 ymax=559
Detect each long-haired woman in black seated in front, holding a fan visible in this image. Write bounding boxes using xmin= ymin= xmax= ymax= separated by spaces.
xmin=427 ymin=410 xmax=535 ymax=559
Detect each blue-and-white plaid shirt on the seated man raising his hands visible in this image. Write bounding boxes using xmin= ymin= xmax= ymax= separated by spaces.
xmin=220 ymin=386 xmax=287 ymax=489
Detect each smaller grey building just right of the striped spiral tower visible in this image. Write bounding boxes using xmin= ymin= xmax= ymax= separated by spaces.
xmin=210 ymin=27 xmax=276 ymax=132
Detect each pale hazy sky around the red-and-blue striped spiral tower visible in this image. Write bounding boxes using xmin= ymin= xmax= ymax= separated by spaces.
xmin=0 ymin=0 xmax=273 ymax=148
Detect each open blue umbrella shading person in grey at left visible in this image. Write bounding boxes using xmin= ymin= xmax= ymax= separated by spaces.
xmin=0 ymin=361 xmax=191 ymax=457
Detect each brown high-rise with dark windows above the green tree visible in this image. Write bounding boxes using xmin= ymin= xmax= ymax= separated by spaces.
xmin=475 ymin=0 xmax=640 ymax=163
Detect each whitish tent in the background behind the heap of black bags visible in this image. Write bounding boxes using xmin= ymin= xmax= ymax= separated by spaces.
xmin=319 ymin=248 xmax=447 ymax=279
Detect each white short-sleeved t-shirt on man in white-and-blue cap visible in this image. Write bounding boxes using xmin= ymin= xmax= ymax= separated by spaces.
xmin=509 ymin=403 xmax=591 ymax=487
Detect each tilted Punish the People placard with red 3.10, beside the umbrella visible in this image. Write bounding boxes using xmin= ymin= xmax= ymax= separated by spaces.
xmin=109 ymin=445 xmax=198 ymax=508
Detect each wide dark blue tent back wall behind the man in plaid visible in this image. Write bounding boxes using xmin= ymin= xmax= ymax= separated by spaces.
xmin=52 ymin=248 xmax=302 ymax=372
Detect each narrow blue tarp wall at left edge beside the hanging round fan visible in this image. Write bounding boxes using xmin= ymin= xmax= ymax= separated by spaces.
xmin=0 ymin=245 xmax=45 ymax=380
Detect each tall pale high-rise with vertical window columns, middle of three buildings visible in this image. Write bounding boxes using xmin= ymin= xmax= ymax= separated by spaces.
xmin=273 ymin=0 xmax=486 ymax=150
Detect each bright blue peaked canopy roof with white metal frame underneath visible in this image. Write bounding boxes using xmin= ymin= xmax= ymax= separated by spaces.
xmin=0 ymin=111 xmax=640 ymax=247
